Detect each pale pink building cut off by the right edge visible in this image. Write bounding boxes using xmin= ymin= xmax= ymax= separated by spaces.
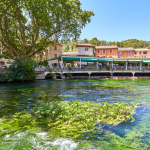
xmin=134 ymin=49 xmax=150 ymax=58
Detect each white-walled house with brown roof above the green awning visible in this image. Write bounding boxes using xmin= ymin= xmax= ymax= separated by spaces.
xmin=76 ymin=44 xmax=95 ymax=56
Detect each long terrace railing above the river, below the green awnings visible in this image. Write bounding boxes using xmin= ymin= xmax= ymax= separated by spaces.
xmin=35 ymin=66 xmax=150 ymax=72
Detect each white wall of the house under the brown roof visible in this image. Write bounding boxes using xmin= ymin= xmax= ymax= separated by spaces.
xmin=77 ymin=47 xmax=93 ymax=56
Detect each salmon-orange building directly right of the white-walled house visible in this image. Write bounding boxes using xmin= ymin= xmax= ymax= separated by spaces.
xmin=95 ymin=46 xmax=118 ymax=58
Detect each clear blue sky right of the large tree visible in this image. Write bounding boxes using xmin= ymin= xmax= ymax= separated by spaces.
xmin=80 ymin=0 xmax=150 ymax=42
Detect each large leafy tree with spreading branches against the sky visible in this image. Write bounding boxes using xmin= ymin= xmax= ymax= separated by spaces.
xmin=0 ymin=0 xmax=94 ymax=58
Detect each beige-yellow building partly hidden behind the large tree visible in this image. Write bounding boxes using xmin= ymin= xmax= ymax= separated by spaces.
xmin=37 ymin=41 xmax=62 ymax=67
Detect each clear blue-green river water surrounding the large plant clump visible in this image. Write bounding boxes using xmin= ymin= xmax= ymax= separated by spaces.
xmin=0 ymin=79 xmax=150 ymax=150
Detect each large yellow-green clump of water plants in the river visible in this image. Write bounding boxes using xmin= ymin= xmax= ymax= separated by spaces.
xmin=0 ymin=100 xmax=136 ymax=138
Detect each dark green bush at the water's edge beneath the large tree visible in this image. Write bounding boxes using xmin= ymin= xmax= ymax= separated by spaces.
xmin=0 ymin=57 xmax=37 ymax=82
